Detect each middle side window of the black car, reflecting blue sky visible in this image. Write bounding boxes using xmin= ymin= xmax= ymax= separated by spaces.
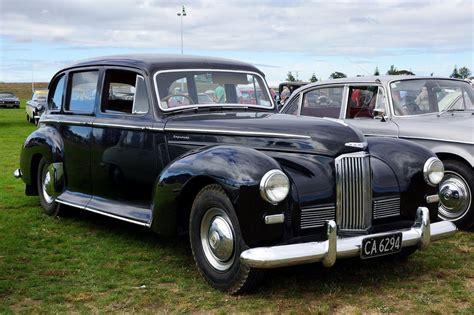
xmin=68 ymin=70 xmax=99 ymax=113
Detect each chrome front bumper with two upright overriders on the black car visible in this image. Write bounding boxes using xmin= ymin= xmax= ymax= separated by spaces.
xmin=240 ymin=207 xmax=456 ymax=268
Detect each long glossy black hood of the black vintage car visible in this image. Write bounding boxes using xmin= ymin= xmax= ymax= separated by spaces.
xmin=165 ymin=112 xmax=366 ymax=157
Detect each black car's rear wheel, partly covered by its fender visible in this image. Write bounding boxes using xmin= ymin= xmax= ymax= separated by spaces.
xmin=37 ymin=157 xmax=61 ymax=216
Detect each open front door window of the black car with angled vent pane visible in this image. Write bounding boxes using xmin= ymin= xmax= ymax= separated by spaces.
xmin=101 ymin=69 xmax=149 ymax=114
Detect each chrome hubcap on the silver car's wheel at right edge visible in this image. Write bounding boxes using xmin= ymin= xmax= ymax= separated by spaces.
xmin=438 ymin=171 xmax=472 ymax=221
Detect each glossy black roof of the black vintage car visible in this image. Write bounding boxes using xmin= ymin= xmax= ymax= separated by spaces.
xmin=61 ymin=54 xmax=264 ymax=76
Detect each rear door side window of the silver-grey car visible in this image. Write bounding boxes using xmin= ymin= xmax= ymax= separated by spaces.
xmin=301 ymin=86 xmax=344 ymax=118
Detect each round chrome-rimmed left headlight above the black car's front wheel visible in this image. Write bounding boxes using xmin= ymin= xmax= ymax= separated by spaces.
xmin=260 ymin=170 xmax=290 ymax=204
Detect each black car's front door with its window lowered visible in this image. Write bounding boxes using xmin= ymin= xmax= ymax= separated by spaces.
xmin=89 ymin=68 xmax=157 ymax=223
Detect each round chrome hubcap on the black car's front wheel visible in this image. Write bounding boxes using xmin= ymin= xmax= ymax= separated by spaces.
xmin=200 ymin=208 xmax=235 ymax=271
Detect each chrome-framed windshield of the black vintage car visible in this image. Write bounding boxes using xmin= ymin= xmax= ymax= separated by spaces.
xmin=155 ymin=70 xmax=273 ymax=111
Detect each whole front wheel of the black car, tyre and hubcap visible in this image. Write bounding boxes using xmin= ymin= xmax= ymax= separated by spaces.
xmin=189 ymin=184 xmax=262 ymax=294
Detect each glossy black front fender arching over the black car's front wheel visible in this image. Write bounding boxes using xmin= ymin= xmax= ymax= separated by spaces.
xmin=152 ymin=145 xmax=285 ymax=245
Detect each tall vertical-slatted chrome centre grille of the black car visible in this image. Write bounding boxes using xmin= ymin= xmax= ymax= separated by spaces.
xmin=336 ymin=152 xmax=372 ymax=230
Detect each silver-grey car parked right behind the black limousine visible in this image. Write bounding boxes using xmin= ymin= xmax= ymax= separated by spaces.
xmin=281 ymin=76 xmax=474 ymax=228
